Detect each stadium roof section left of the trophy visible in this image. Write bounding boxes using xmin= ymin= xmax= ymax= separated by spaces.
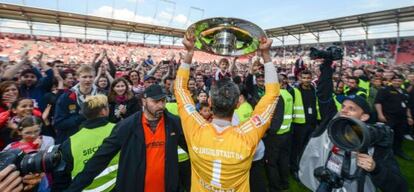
xmin=0 ymin=3 xmax=185 ymax=38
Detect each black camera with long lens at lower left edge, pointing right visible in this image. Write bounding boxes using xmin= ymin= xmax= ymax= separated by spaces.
xmin=0 ymin=145 xmax=62 ymax=175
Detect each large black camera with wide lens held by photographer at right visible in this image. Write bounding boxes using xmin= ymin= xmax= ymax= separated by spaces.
xmin=314 ymin=117 xmax=393 ymax=192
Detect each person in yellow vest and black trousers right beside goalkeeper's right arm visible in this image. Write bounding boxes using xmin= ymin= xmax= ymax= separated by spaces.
xmin=263 ymin=74 xmax=294 ymax=192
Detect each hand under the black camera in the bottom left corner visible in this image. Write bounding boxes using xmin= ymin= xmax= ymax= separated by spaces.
xmin=0 ymin=165 xmax=41 ymax=192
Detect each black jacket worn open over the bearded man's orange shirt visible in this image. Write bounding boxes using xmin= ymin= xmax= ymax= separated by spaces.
xmin=67 ymin=112 xmax=183 ymax=192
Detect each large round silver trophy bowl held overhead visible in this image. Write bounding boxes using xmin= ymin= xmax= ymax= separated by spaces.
xmin=186 ymin=17 xmax=266 ymax=56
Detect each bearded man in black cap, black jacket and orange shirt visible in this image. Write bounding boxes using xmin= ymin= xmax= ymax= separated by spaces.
xmin=67 ymin=84 xmax=185 ymax=192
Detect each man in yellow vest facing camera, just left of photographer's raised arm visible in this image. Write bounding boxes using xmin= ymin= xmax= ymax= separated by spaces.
xmin=290 ymin=70 xmax=319 ymax=175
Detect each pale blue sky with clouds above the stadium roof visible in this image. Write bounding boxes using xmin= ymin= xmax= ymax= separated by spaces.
xmin=0 ymin=0 xmax=414 ymax=29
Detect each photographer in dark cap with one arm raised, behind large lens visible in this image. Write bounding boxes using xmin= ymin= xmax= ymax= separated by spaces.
xmin=299 ymin=54 xmax=408 ymax=192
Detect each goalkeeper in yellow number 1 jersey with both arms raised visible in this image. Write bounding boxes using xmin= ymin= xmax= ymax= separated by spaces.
xmin=174 ymin=32 xmax=280 ymax=192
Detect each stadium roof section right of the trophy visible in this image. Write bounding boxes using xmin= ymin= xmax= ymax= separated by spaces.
xmin=265 ymin=6 xmax=414 ymax=37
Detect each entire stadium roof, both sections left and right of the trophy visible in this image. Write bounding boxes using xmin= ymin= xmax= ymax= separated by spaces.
xmin=0 ymin=3 xmax=414 ymax=38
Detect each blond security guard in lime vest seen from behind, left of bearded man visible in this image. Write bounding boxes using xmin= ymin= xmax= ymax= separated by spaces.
xmin=52 ymin=95 xmax=119 ymax=191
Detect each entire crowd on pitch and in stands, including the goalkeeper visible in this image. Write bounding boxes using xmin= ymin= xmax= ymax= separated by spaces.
xmin=0 ymin=30 xmax=414 ymax=192
